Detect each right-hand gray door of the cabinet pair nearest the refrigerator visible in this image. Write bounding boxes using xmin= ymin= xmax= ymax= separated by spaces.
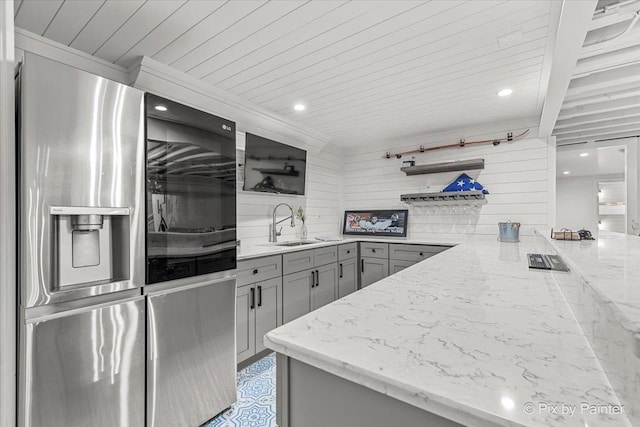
xmin=255 ymin=277 xmax=282 ymax=353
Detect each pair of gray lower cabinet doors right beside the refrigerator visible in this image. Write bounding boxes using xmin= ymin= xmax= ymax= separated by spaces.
xmin=236 ymin=277 xmax=282 ymax=363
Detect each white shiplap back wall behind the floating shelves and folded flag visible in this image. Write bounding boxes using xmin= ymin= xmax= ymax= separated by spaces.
xmin=343 ymin=127 xmax=555 ymax=238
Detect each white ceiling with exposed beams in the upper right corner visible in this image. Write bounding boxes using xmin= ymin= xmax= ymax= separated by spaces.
xmin=553 ymin=0 xmax=640 ymax=145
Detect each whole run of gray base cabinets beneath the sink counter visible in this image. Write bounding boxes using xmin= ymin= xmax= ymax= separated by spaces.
xmin=242 ymin=242 xmax=448 ymax=338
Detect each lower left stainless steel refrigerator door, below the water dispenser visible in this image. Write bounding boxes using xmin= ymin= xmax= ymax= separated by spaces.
xmin=19 ymin=296 xmax=145 ymax=427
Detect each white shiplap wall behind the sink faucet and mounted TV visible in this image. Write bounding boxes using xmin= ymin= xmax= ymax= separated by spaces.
xmin=236 ymin=132 xmax=342 ymax=245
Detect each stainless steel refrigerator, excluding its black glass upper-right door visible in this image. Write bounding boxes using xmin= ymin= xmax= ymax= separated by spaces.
xmin=16 ymin=53 xmax=235 ymax=427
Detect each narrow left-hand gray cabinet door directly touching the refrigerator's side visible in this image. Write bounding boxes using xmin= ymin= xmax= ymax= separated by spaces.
xmin=236 ymin=285 xmax=256 ymax=363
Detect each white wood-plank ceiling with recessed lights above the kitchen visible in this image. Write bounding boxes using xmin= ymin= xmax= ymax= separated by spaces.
xmin=15 ymin=0 xmax=559 ymax=144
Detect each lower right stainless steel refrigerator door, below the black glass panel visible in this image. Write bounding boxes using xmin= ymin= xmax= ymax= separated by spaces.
xmin=147 ymin=278 xmax=236 ymax=427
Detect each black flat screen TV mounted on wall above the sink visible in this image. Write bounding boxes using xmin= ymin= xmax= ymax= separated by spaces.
xmin=243 ymin=133 xmax=307 ymax=195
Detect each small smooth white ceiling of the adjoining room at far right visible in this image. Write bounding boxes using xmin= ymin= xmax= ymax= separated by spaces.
xmin=556 ymin=143 xmax=626 ymax=178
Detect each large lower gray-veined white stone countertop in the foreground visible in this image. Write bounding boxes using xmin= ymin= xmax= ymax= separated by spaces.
xmin=264 ymin=237 xmax=631 ymax=427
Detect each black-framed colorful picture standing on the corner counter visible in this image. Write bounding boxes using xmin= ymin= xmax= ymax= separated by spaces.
xmin=342 ymin=209 xmax=409 ymax=237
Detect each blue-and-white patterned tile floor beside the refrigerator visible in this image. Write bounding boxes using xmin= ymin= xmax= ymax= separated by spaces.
xmin=205 ymin=353 xmax=278 ymax=427
